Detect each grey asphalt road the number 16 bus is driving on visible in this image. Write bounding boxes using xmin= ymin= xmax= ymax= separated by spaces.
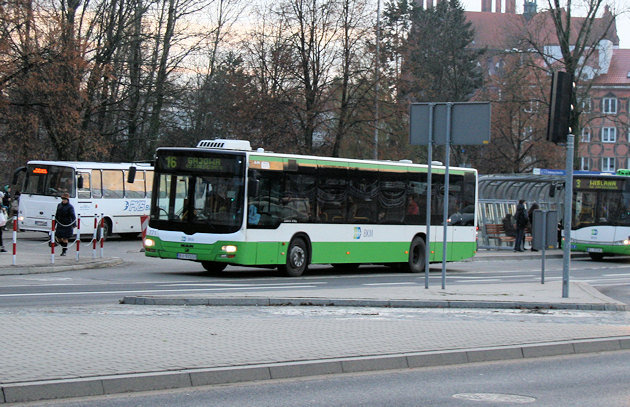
xmin=0 ymin=238 xmax=630 ymax=307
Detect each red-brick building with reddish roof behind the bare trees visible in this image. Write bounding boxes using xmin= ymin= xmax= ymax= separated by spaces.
xmin=460 ymin=0 xmax=630 ymax=171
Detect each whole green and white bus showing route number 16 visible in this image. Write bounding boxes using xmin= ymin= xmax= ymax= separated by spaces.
xmin=144 ymin=140 xmax=477 ymax=276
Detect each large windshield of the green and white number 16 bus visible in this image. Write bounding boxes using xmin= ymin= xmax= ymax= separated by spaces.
xmin=151 ymin=152 xmax=244 ymax=234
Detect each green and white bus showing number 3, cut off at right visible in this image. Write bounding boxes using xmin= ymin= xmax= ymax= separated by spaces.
xmin=571 ymin=170 xmax=630 ymax=260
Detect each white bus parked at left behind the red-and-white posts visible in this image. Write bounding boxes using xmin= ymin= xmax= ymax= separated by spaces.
xmin=14 ymin=161 xmax=153 ymax=236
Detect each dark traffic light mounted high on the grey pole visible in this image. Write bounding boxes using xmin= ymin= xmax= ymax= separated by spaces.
xmin=547 ymin=71 xmax=574 ymax=144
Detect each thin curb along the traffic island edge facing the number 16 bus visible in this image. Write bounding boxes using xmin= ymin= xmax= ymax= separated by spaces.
xmin=120 ymin=296 xmax=630 ymax=311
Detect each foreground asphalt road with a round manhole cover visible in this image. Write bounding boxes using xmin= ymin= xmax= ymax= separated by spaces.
xmin=13 ymin=351 xmax=630 ymax=407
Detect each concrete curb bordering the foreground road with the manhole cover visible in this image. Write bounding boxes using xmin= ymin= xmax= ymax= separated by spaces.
xmin=0 ymin=336 xmax=630 ymax=403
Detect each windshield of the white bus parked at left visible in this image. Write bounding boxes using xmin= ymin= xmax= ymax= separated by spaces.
xmin=22 ymin=164 xmax=76 ymax=198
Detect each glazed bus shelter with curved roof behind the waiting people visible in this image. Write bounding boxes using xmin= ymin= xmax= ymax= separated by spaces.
xmin=477 ymin=174 xmax=564 ymax=249
